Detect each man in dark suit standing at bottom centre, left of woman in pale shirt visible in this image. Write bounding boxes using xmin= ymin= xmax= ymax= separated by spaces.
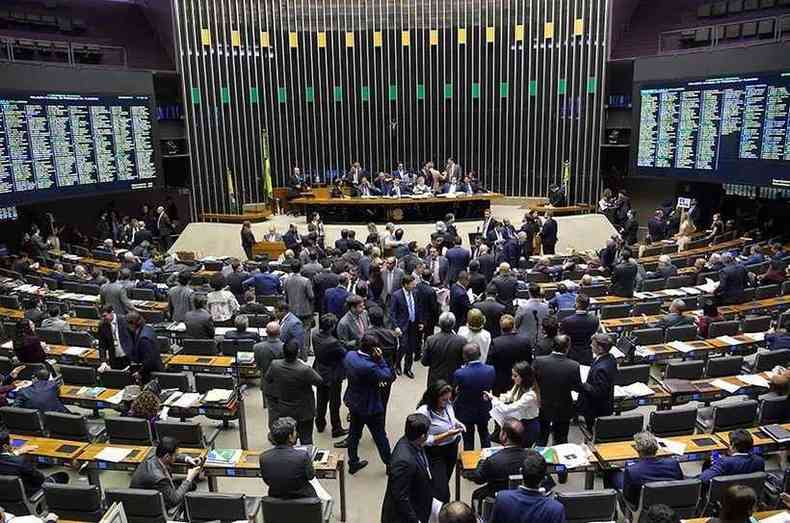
xmin=381 ymin=414 xmax=433 ymax=523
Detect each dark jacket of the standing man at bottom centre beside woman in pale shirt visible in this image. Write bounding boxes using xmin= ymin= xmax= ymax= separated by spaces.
xmin=381 ymin=437 xmax=433 ymax=523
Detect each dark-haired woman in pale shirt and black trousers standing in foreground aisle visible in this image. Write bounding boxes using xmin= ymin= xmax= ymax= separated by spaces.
xmin=417 ymin=380 xmax=466 ymax=503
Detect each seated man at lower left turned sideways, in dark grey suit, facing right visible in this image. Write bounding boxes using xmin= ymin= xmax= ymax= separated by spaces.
xmin=129 ymin=436 xmax=201 ymax=510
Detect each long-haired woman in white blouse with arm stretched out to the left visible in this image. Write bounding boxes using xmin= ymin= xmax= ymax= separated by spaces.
xmin=483 ymin=361 xmax=540 ymax=448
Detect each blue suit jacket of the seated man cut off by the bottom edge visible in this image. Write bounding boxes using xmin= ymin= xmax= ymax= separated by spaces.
xmin=489 ymin=487 xmax=565 ymax=523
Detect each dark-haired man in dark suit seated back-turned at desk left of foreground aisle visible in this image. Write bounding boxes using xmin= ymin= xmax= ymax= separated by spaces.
xmin=260 ymin=416 xmax=316 ymax=499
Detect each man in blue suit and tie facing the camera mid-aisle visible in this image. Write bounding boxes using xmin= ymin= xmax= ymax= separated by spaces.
xmin=389 ymin=274 xmax=423 ymax=379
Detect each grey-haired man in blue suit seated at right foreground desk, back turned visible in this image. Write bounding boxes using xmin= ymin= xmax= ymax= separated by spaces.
xmin=606 ymin=431 xmax=683 ymax=506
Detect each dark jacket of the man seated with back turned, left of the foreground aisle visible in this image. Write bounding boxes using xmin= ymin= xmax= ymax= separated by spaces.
xmin=260 ymin=445 xmax=316 ymax=499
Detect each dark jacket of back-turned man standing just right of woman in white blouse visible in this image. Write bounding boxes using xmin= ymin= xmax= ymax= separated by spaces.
xmin=532 ymin=352 xmax=582 ymax=421
